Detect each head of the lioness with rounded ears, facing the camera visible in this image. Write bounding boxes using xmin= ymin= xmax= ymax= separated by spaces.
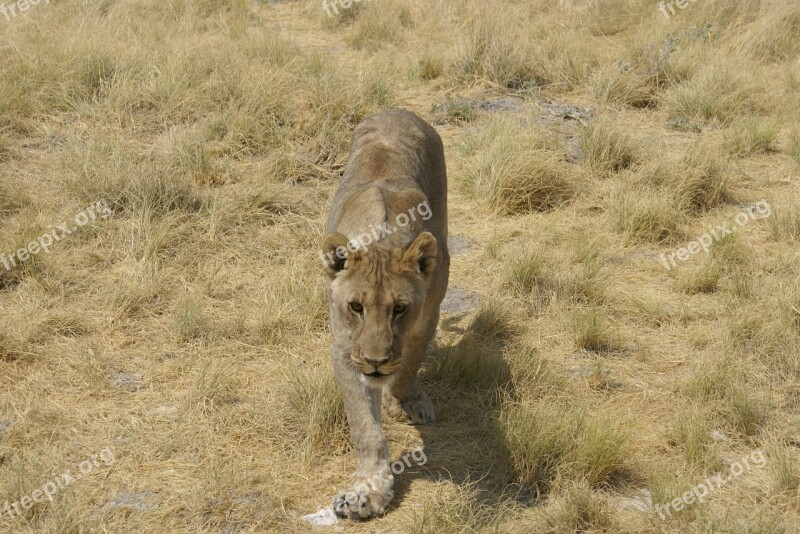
xmin=323 ymin=232 xmax=437 ymax=380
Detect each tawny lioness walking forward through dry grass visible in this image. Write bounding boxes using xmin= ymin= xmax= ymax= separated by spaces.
xmin=322 ymin=110 xmax=450 ymax=519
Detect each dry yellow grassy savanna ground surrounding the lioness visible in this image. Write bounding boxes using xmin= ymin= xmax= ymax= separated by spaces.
xmin=0 ymin=0 xmax=800 ymax=533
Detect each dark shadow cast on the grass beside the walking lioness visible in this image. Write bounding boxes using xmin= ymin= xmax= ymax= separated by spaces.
xmin=392 ymin=306 xmax=535 ymax=520
